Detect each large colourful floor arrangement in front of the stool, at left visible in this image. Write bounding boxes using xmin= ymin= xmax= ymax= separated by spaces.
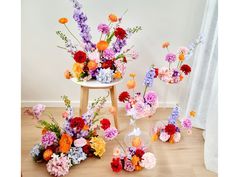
xmin=26 ymin=96 xmax=118 ymax=176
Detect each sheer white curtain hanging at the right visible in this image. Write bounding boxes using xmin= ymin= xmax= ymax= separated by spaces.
xmin=181 ymin=0 xmax=218 ymax=172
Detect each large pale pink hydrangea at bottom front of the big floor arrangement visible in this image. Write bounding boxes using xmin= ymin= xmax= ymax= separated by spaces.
xmin=46 ymin=154 xmax=71 ymax=177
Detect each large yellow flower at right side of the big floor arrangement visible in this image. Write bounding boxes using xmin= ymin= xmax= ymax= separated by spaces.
xmin=90 ymin=137 xmax=106 ymax=157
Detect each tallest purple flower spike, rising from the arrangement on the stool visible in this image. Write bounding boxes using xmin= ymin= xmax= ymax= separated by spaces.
xmin=72 ymin=0 xmax=96 ymax=51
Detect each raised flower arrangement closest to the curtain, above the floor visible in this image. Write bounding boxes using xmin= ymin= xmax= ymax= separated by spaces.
xmin=158 ymin=36 xmax=203 ymax=84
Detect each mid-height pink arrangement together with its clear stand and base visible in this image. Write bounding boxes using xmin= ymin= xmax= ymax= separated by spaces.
xmin=119 ymin=65 xmax=158 ymax=148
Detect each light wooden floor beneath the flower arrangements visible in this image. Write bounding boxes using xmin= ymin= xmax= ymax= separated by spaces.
xmin=21 ymin=108 xmax=217 ymax=177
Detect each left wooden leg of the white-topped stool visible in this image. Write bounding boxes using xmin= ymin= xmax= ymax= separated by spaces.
xmin=80 ymin=86 xmax=89 ymax=115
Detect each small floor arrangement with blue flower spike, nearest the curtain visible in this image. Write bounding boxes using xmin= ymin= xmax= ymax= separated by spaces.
xmin=152 ymin=106 xmax=196 ymax=144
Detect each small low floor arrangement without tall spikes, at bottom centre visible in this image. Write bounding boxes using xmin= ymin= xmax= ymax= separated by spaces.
xmin=111 ymin=147 xmax=156 ymax=173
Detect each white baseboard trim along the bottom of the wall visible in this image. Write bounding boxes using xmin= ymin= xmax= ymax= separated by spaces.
xmin=21 ymin=100 xmax=177 ymax=108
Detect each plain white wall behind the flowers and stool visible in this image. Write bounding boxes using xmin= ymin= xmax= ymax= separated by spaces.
xmin=22 ymin=0 xmax=205 ymax=106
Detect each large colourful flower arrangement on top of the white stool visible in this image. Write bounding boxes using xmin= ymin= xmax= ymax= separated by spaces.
xmin=56 ymin=0 xmax=141 ymax=83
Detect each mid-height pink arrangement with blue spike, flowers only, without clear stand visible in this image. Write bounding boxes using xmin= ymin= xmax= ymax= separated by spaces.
xmin=119 ymin=65 xmax=158 ymax=120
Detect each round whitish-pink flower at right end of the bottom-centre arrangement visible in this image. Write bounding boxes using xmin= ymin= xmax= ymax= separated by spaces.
xmin=140 ymin=152 xmax=156 ymax=169
